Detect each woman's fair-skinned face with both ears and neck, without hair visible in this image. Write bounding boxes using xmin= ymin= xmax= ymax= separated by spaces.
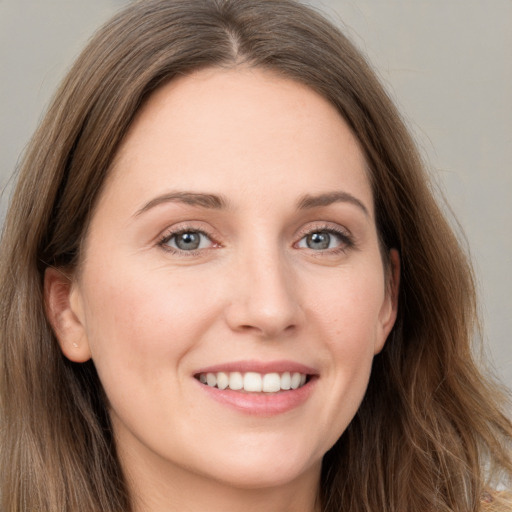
xmin=45 ymin=68 xmax=398 ymax=512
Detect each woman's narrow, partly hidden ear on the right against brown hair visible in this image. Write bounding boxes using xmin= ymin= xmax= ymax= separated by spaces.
xmin=374 ymin=249 xmax=400 ymax=354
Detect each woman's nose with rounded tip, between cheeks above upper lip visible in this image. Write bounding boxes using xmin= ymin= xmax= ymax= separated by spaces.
xmin=225 ymin=251 xmax=302 ymax=339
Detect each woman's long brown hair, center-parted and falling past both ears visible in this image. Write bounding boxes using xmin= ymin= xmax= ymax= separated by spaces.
xmin=0 ymin=0 xmax=512 ymax=512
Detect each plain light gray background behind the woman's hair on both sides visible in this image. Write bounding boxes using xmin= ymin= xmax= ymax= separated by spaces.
xmin=0 ymin=0 xmax=512 ymax=387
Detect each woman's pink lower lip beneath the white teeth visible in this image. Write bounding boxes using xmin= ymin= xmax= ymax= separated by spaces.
xmin=196 ymin=378 xmax=318 ymax=416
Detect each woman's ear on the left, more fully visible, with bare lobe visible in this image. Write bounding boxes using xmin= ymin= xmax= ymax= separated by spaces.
xmin=44 ymin=268 xmax=91 ymax=363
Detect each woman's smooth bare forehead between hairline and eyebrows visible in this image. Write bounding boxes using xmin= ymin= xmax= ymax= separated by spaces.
xmin=101 ymin=68 xmax=371 ymax=215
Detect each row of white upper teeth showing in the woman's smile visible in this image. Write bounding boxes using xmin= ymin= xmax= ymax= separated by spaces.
xmin=198 ymin=372 xmax=307 ymax=393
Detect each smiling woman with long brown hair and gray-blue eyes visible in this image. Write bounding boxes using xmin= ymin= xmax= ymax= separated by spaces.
xmin=0 ymin=0 xmax=512 ymax=512
